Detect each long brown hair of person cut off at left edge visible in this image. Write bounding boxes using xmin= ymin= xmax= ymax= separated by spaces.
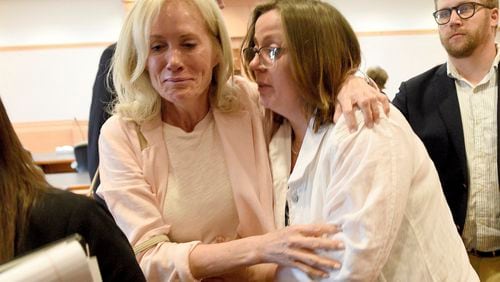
xmin=0 ymin=99 xmax=49 ymax=264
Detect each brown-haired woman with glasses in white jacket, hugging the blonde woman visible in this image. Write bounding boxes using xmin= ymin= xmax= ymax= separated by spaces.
xmin=243 ymin=0 xmax=479 ymax=282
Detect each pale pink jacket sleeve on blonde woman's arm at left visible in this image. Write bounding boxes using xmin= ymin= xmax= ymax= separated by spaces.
xmin=97 ymin=117 xmax=199 ymax=281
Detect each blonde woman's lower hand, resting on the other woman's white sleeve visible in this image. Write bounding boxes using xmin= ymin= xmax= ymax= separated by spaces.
xmin=255 ymin=224 xmax=343 ymax=278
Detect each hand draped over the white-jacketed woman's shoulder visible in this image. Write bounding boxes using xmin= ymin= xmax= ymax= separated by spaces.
xmin=333 ymin=75 xmax=389 ymax=131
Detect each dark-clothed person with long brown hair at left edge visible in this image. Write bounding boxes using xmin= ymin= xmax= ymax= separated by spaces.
xmin=0 ymin=96 xmax=145 ymax=281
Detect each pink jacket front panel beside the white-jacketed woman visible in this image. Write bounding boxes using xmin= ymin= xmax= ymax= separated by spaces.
xmin=214 ymin=110 xmax=274 ymax=237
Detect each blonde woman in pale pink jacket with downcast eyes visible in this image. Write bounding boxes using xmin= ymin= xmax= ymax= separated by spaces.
xmin=97 ymin=0 xmax=385 ymax=281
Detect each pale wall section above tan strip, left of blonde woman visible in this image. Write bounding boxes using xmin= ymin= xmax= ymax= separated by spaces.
xmin=0 ymin=0 xmax=124 ymax=46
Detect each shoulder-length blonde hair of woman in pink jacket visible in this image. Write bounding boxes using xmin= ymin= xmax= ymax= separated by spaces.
xmin=110 ymin=0 xmax=239 ymax=123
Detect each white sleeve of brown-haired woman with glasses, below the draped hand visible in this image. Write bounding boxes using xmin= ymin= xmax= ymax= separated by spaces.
xmin=323 ymin=112 xmax=414 ymax=281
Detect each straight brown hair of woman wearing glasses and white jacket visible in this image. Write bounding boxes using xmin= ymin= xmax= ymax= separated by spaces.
xmin=242 ymin=0 xmax=361 ymax=130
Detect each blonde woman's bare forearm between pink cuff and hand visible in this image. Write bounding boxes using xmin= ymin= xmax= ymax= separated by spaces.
xmin=189 ymin=236 xmax=268 ymax=279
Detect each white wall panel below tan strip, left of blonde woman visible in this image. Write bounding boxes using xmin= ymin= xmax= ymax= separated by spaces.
xmin=0 ymin=44 xmax=110 ymax=122
